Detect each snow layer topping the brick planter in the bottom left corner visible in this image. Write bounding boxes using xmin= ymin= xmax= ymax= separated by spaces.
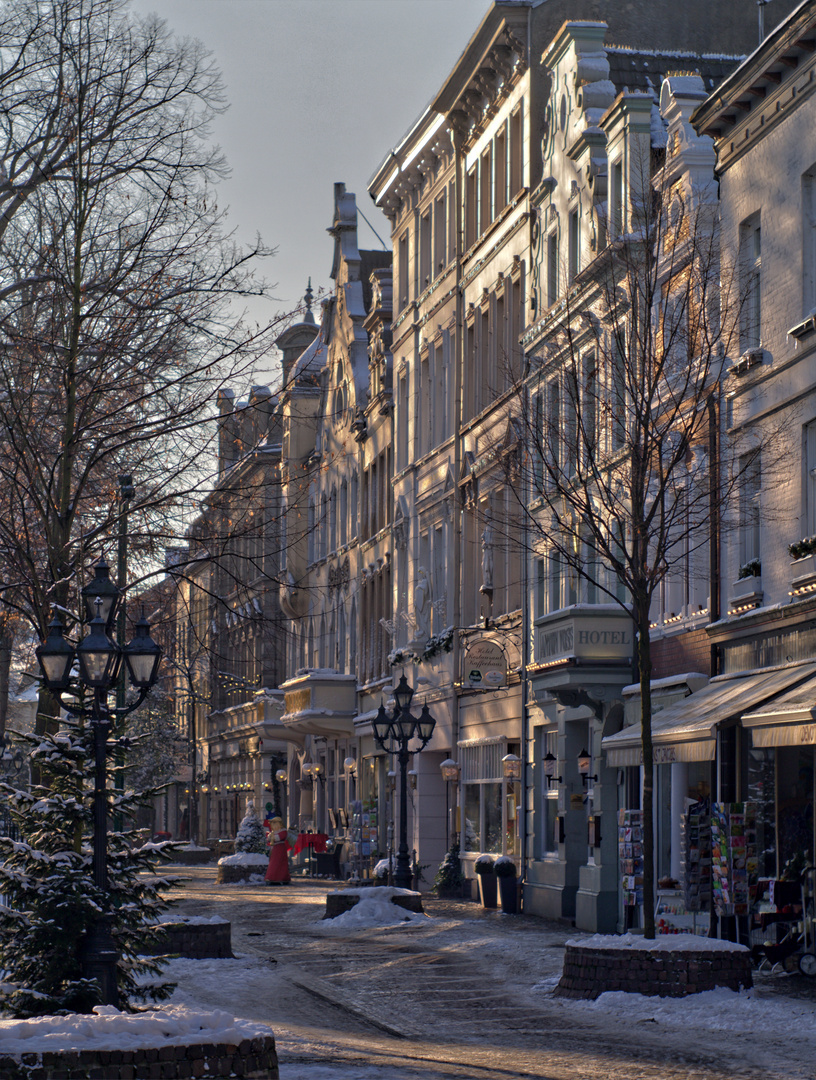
xmin=0 ymin=1005 xmax=273 ymax=1055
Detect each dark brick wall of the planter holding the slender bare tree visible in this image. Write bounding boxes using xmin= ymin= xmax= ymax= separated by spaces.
xmin=555 ymin=944 xmax=753 ymax=1000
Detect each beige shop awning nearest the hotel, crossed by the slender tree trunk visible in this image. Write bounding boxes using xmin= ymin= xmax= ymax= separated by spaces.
xmin=602 ymin=664 xmax=816 ymax=768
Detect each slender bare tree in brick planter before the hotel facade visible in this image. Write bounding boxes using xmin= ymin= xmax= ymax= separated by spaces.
xmin=507 ymin=111 xmax=785 ymax=936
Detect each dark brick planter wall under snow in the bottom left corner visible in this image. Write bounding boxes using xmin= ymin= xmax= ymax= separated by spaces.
xmin=0 ymin=1036 xmax=280 ymax=1080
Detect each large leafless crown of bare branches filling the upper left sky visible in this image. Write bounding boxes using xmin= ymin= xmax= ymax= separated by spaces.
xmin=0 ymin=0 xmax=280 ymax=717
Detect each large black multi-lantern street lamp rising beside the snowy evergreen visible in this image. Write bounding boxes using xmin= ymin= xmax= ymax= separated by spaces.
xmin=37 ymin=559 xmax=162 ymax=1005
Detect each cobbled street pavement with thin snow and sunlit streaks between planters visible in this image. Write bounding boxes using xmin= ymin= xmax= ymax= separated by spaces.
xmin=164 ymin=867 xmax=816 ymax=1080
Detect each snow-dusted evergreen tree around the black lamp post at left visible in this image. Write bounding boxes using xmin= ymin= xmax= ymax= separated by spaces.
xmin=0 ymin=719 xmax=173 ymax=1017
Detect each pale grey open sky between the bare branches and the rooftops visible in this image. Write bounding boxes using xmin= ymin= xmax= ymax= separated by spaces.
xmin=133 ymin=0 xmax=489 ymax=378
